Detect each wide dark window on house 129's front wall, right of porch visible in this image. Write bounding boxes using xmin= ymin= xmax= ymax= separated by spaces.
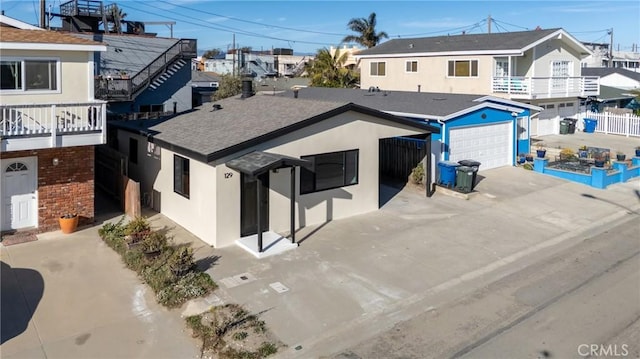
xmin=300 ymin=150 xmax=358 ymax=194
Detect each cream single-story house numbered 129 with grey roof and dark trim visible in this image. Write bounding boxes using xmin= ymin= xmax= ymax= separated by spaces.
xmin=110 ymin=88 xmax=439 ymax=252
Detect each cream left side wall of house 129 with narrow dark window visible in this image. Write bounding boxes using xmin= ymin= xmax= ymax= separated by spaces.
xmin=153 ymin=148 xmax=219 ymax=245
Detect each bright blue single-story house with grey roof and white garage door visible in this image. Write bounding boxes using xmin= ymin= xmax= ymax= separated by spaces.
xmin=279 ymin=87 xmax=541 ymax=175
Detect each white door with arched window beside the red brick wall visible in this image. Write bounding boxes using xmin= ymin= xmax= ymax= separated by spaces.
xmin=1 ymin=157 xmax=38 ymax=230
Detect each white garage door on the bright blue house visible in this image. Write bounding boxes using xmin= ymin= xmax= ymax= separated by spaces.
xmin=449 ymin=122 xmax=513 ymax=170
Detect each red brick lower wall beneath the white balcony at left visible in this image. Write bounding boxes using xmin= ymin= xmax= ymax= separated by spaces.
xmin=0 ymin=146 xmax=95 ymax=232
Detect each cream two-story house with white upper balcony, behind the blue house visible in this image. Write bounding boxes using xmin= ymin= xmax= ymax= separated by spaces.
xmin=356 ymin=29 xmax=599 ymax=135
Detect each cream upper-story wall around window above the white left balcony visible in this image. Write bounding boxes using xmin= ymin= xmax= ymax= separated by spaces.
xmin=2 ymin=50 xmax=93 ymax=105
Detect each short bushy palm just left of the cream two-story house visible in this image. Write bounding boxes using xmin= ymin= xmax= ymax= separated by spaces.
xmin=306 ymin=48 xmax=358 ymax=87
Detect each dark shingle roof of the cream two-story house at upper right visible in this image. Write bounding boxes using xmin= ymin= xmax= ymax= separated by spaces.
xmin=357 ymin=29 xmax=561 ymax=57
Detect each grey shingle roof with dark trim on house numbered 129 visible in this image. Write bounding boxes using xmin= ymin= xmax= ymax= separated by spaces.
xmin=113 ymin=95 xmax=439 ymax=162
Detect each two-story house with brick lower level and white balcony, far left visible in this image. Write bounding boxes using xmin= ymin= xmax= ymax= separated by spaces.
xmin=0 ymin=22 xmax=106 ymax=232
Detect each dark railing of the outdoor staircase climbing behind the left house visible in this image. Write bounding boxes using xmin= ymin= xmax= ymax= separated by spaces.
xmin=95 ymin=39 xmax=197 ymax=101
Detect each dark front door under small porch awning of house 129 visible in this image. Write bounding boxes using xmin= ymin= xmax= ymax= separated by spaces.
xmin=240 ymin=173 xmax=269 ymax=237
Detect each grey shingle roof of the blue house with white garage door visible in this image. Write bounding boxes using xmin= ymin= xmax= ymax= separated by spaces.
xmin=279 ymin=87 xmax=483 ymax=117
